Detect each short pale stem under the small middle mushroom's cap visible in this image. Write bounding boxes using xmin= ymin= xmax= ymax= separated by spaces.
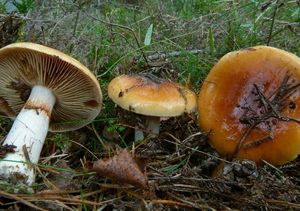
xmin=134 ymin=116 xmax=160 ymax=141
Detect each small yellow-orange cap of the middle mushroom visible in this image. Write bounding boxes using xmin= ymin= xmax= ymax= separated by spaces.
xmin=108 ymin=74 xmax=197 ymax=117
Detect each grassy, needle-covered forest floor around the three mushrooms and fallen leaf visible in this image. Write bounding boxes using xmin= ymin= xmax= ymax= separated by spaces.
xmin=0 ymin=0 xmax=300 ymax=210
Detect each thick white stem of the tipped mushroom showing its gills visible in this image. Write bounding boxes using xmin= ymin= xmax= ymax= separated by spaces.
xmin=0 ymin=86 xmax=55 ymax=185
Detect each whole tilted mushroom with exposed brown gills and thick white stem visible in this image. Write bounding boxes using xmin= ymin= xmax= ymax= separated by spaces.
xmin=0 ymin=43 xmax=102 ymax=185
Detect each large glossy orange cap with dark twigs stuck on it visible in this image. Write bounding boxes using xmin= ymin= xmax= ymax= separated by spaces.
xmin=198 ymin=46 xmax=300 ymax=165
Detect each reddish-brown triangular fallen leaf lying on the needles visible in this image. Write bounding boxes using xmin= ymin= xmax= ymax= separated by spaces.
xmin=92 ymin=149 xmax=148 ymax=189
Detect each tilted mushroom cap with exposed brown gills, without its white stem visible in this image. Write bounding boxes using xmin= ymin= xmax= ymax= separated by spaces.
xmin=0 ymin=43 xmax=102 ymax=131
